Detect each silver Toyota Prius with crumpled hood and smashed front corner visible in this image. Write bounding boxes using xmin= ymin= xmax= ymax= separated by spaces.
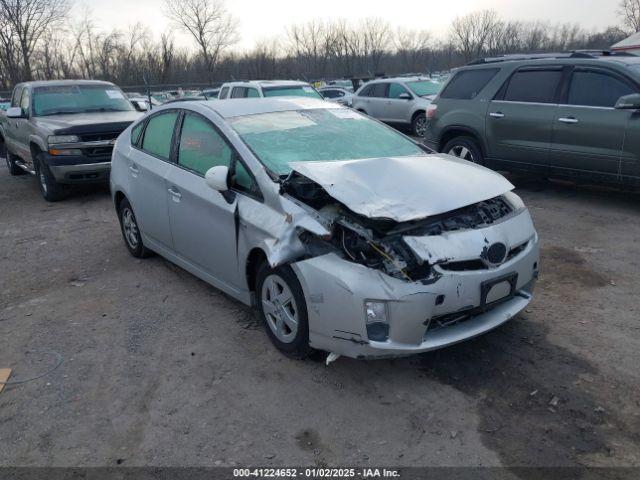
xmin=111 ymin=97 xmax=538 ymax=358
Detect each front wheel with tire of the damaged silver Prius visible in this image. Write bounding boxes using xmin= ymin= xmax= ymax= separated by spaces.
xmin=256 ymin=263 xmax=312 ymax=359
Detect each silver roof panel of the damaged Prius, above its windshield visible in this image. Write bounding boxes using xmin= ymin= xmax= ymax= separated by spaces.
xmin=194 ymin=97 xmax=336 ymax=118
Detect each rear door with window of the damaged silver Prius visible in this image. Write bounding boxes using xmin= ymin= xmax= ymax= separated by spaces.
xmin=128 ymin=110 xmax=179 ymax=249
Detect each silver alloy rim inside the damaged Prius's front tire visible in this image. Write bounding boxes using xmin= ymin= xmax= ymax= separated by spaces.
xmin=261 ymin=274 xmax=299 ymax=343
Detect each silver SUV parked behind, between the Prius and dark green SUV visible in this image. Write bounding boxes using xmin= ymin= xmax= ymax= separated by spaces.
xmin=353 ymin=77 xmax=442 ymax=137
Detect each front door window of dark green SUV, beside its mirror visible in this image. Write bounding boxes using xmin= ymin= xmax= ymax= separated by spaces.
xmin=567 ymin=71 xmax=636 ymax=108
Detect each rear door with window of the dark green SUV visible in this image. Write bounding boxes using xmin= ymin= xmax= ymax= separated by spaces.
xmin=486 ymin=66 xmax=564 ymax=169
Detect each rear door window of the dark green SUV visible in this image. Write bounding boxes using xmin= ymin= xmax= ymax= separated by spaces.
xmin=504 ymin=70 xmax=562 ymax=103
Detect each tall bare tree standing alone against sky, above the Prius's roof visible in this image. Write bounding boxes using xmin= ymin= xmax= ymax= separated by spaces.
xmin=165 ymin=0 xmax=238 ymax=78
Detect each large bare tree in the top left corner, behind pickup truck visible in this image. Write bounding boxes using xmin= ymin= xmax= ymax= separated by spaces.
xmin=0 ymin=0 xmax=70 ymax=80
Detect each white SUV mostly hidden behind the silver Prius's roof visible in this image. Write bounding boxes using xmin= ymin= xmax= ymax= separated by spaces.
xmin=218 ymin=80 xmax=322 ymax=100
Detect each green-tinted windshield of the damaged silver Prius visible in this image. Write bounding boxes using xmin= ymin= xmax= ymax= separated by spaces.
xmin=229 ymin=108 xmax=425 ymax=175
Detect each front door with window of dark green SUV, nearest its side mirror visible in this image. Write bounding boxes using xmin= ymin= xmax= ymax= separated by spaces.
xmin=549 ymin=67 xmax=638 ymax=180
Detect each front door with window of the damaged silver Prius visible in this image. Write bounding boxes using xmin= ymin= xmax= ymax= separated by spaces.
xmin=167 ymin=112 xmax=239 ymax=286
